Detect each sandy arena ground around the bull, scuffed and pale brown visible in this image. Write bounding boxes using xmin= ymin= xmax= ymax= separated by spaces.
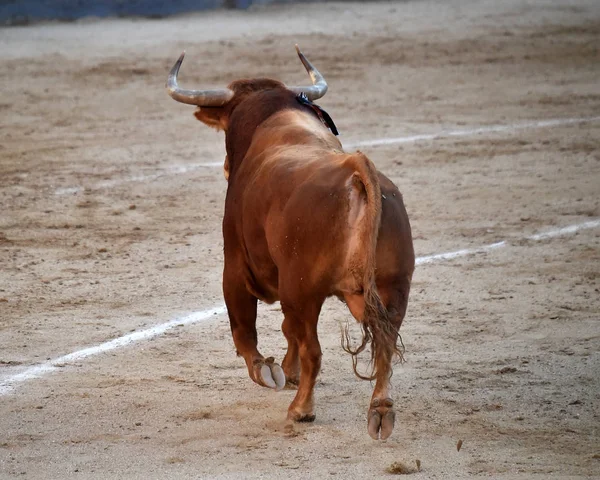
xmin=0 ymin=0 xmax=600 ymax=479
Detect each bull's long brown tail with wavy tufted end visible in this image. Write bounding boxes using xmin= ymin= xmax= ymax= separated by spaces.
xmin=342 ymin=152 xmax=403 ymax=380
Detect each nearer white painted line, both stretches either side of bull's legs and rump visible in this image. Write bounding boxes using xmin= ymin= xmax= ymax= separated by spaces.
xmin=0 ymin=219 xmax=600 ymax=396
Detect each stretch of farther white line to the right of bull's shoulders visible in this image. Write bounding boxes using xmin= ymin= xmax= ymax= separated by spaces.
xmin=344 ymin=116 xmax=600 ymax=148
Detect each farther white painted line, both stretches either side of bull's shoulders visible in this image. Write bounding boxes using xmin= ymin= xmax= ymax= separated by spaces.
xmin=54 ymin=116 xmax=600 ymax=195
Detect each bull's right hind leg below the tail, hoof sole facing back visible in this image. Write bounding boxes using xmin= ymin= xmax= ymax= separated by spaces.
xmin=367 ymin=279 xmax=410 ymax=440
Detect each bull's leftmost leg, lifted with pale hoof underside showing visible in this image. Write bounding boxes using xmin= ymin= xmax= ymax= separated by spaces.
xmin=223 ymin=281 xmax=285 ymax=390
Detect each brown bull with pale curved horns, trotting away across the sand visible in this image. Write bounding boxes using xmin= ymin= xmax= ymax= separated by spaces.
xmin=167 ymin=47 xmax=414 ymax=439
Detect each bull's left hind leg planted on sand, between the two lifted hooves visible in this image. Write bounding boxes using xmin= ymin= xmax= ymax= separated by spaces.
xmin=281 ymin=298 xmax=323 ymax=422
